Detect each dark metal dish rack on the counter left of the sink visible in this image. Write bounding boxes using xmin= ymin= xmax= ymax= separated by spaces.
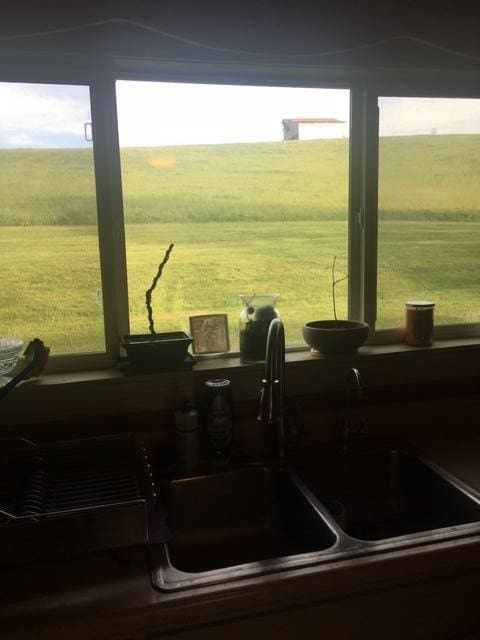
xmin=0 ymin=434 xmax=154 ymax=565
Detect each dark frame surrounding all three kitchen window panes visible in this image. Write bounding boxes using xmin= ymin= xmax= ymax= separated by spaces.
xmin=0 ymin=53 xmax=480 ymax=372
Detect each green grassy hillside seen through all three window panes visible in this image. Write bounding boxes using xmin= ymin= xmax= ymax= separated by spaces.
xmin=0 ymin=135 xmax=480 ymax=353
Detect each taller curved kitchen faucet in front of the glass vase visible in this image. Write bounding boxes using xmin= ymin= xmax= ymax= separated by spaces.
xmin=258 ymin=318 xmax=286 ymax=459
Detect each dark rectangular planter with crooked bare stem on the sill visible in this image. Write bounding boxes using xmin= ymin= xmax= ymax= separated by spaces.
xmin=122 ymin=243 xmax=194 ymax=370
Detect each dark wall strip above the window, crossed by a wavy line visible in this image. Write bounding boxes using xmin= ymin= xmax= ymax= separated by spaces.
xmin=0 ymin=0 xmax=480 ymax=68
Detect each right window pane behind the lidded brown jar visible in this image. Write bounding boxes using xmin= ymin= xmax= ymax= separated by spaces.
xmin=377 ymin=98 xmax=480 ymax=328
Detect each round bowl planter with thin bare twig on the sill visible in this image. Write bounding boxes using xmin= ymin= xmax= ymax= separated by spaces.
xmin=302 ymin=256 xmax=368 ymax=354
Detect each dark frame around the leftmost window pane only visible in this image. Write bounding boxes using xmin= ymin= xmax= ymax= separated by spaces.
xmin=0 ymin=68 xmax=128 ymax=373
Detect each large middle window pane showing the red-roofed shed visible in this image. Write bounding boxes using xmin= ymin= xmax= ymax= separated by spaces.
xmin=117 ymin=81 xmax=350 ymax=347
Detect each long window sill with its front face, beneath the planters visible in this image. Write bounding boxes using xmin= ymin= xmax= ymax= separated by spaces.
xmin=0 ymin=338 xmax=480 ymax=426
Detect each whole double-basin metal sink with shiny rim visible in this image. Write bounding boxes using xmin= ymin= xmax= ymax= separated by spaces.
xmin=151 ymin=446 xmax=480 ymax=590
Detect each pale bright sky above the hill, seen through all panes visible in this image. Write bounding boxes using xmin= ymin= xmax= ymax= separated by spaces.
xmin=0 ymin=81 xmax=480 ymax=148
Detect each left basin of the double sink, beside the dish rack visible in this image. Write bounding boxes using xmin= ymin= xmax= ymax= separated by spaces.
xmin=154 ymin=467 xmax=337 ymax=584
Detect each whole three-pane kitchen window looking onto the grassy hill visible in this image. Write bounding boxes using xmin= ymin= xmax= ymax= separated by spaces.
xmin=0 ymin=62 xmax=480 ymax=368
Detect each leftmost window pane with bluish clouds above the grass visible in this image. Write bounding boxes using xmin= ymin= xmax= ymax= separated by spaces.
xmin=0 ymin=83 xmax=105 ymax=354
